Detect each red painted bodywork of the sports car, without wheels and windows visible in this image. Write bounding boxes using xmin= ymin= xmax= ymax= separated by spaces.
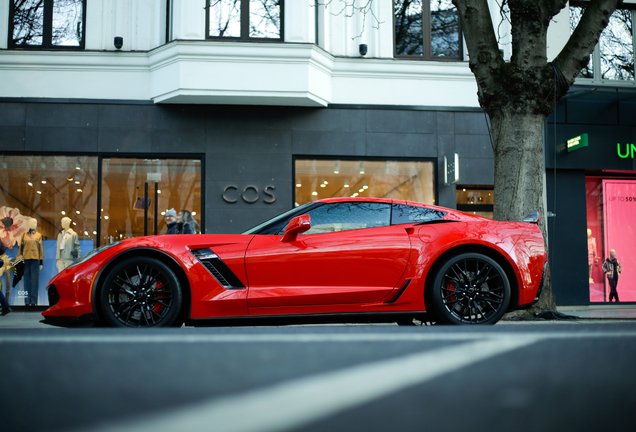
xmin=42 ymin=199 xmax=547 ymax=326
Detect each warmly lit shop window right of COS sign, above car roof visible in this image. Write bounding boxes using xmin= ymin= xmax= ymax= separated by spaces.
xmin=295 ymin=159 xmax=435 ymax=205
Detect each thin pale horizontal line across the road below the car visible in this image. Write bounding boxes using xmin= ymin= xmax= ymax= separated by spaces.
xmin=0 ymin=331 xmax=636 ymax=344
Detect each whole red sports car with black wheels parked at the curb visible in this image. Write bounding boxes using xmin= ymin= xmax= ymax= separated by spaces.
xmin=42 ymin=198 xmax=547 ymax=327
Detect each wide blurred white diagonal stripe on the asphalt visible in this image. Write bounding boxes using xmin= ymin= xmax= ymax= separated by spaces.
xmin=78 ymin=335 xmax=541 ymax=432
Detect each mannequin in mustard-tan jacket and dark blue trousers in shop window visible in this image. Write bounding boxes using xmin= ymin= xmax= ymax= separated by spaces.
xmin=18 ymin=218 xmax=44 ymax=306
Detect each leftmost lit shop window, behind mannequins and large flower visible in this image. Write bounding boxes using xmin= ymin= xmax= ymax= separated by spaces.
xmin=0 ymin=155 xmax=98 ymax=305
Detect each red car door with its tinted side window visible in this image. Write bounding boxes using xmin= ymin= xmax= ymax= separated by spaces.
xmin=245 ymin=202 xmax=410 ymax=309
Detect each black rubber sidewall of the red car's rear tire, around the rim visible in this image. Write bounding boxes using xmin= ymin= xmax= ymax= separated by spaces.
xmin=426 ymin=253 xmax=511 ymax=325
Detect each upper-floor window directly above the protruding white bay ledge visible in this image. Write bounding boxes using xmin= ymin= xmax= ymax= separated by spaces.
xmin=206 ymin=0 xmax=284 ymax=41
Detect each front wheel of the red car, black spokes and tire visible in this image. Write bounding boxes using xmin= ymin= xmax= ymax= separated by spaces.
xmin=99 ymin=257 xmax=183 ymax=327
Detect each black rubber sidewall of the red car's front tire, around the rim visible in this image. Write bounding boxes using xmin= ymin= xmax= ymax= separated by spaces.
xmin=98 ymin=257 xmax=183 ymax=327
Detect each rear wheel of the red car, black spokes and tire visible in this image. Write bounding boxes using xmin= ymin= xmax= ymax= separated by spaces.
xmin=426 ymin=253 xmax=510 ymax=325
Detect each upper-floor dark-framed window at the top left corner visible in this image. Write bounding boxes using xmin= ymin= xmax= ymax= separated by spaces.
xmin=9 ymin=0 xmax=86 ymax=49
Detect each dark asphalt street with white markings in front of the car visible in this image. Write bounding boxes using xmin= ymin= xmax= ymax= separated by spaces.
xmin=0 ymin=314 xmax=636 ymax=432
